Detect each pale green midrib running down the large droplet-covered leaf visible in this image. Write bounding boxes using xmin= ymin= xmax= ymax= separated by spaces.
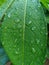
xmin=22 ymin=0 xmax=27 ymax=65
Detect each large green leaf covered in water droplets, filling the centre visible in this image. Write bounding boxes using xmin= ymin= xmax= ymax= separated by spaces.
xmin=2 ymin=0 xmax=46 ymax=65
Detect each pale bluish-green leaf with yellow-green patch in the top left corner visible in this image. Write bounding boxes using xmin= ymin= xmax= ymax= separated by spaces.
xmin=0 ymin=0 xmax=14 ymax=20
